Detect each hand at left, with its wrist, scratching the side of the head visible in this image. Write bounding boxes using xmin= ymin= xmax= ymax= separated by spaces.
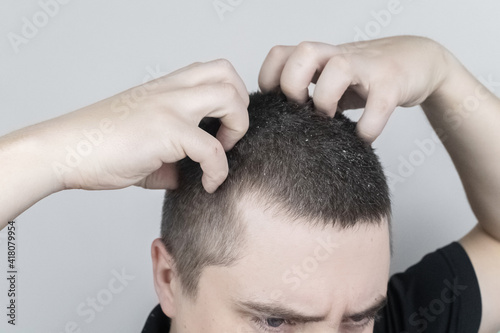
xmin=29 ymin=60 xmax=249 ymax=192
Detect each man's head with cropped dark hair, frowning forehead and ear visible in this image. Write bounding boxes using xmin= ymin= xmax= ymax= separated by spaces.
xmin=153 ymin=93 xmax=390 ymax=333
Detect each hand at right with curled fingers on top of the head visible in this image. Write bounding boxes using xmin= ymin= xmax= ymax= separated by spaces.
xmin=259 ymin=36 xmax=458 ymax=143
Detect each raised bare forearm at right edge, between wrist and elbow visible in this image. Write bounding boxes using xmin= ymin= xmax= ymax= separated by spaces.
xmin=422 ymin=58 xmax=500 ymax=240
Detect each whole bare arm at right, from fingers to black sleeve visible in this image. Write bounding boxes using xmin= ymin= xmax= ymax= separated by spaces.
xmin=259 ymin=36 xmax=500 ymax=333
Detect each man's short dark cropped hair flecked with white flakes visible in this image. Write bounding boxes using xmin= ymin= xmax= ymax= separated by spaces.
xmin=161 ymin=92 xmax=391 ymax=297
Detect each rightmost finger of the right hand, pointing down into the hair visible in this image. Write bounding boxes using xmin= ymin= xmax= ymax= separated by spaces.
xmin=356 ymin=86 xmax=398 ymax=144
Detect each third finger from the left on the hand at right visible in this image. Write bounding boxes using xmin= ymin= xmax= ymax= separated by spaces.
xmin=313 ymin=55 xmax=356 ymax=117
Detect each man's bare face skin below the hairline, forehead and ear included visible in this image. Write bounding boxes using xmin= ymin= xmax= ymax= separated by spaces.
xmin=152 ymin=200 xmax=390 ymax=333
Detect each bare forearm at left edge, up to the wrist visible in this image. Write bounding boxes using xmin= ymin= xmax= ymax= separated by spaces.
xmin=0 ymin=127 xmax=61 ymax=229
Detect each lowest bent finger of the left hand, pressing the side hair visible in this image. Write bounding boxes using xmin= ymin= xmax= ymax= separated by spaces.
xmin=181 ymin=128 xmax=229 ymax=193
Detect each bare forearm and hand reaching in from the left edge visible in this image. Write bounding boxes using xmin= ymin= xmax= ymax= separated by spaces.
xmin=0 ymin=59 xmax=249 ymax=228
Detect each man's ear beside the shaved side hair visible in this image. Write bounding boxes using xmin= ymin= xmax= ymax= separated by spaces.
xmin=151 ymin=238 xmax=181 ymax=318
